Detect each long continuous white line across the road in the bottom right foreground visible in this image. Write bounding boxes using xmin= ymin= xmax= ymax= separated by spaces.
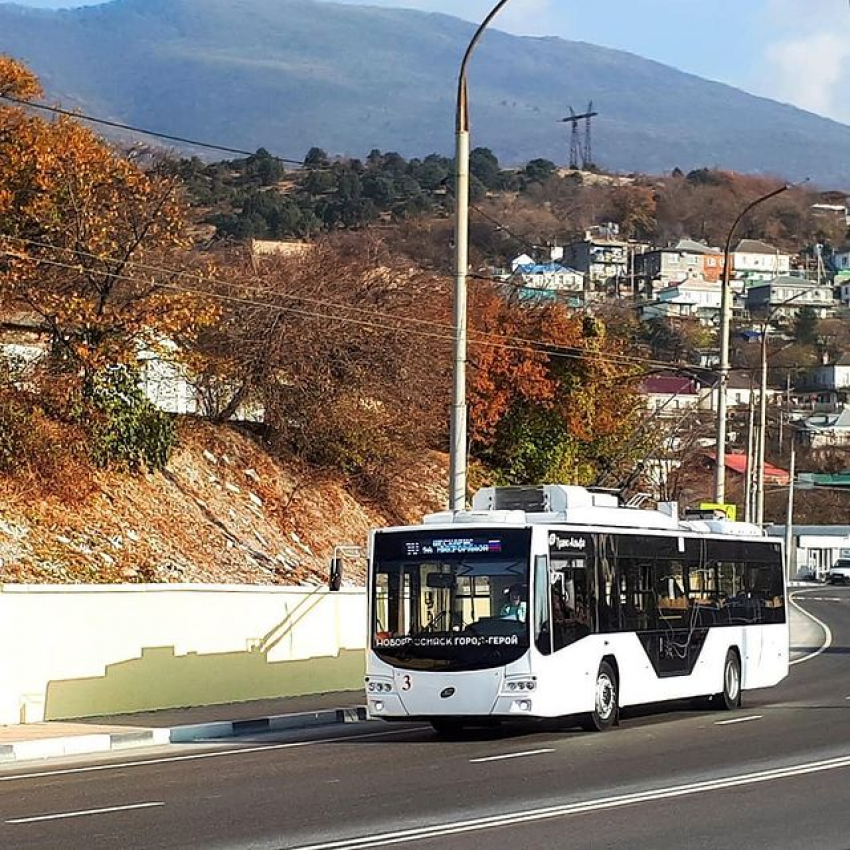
xmin=284 ymin=756 xmax=850 ymax=850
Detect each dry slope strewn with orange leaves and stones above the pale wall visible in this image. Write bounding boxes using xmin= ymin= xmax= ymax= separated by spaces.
xmin=0 ymin=420 xmax=447 ymax=584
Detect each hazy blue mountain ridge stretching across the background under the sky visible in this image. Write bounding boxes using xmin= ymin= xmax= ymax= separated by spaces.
xmin=0 ymin=0 xmax=850 ymax=188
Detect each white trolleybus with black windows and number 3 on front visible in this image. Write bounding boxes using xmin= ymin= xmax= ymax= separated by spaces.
xmin=366 ymin=485 xmax=788 ymax=734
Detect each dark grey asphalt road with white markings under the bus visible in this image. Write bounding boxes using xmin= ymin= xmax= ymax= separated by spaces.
xmin=0 ymin=587 xmax=850 ymax=850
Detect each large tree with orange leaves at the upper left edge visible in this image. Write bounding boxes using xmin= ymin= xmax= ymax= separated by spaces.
xmin=0 ymin=56 xmax=214 ymax=378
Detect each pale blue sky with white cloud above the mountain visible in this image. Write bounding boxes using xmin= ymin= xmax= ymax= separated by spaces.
xmin=11 ymin=0 xmax=850 ymax=124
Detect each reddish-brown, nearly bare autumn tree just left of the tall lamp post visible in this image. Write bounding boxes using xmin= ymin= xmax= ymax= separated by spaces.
xmin=189 ymin=234 xmax=452 ymax=495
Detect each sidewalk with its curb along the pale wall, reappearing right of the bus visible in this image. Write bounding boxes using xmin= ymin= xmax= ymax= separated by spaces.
xmin=0 ymin=596 xmax=823 ymax=765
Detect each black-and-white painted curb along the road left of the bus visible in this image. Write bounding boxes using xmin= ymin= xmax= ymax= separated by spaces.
xmin=0 ymin=705 xmax=368 ymax=765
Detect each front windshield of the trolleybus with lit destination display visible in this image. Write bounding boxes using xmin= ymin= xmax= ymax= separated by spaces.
xmin=372 ymin=528 xmax=531 ymax=670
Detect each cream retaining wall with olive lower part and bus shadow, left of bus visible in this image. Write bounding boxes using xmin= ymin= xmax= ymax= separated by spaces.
xmin=0 ymin=584 xmax=366 ymax=724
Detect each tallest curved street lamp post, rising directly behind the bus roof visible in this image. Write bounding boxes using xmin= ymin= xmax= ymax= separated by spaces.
xmin=449 ymin=0 xmax=508 ymax=511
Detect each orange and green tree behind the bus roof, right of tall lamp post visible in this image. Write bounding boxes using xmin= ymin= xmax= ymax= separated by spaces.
xmin=469 ymin=293 xmax=643 ymax=484
